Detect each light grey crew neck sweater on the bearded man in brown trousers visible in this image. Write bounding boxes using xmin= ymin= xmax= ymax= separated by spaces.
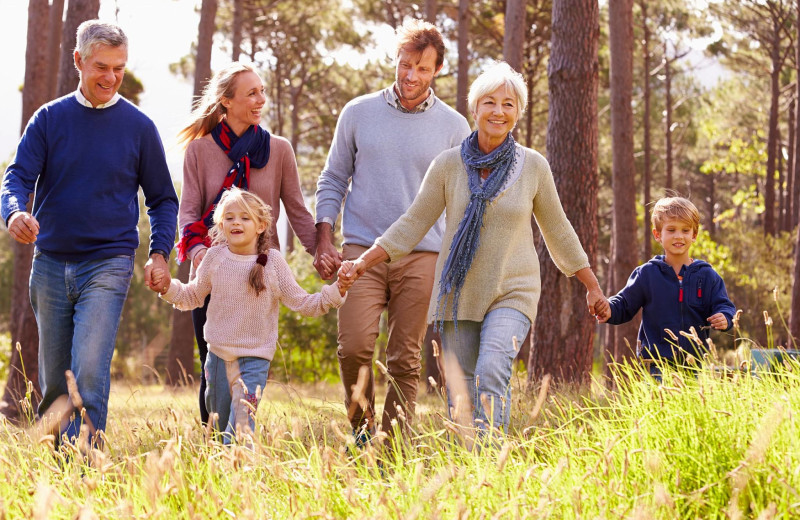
xmin=316 ymin=87 xmax=470 ymax=252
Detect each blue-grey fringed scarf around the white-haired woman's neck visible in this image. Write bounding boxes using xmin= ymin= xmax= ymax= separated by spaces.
xmin=435 ymin=131 xmax=516 ymax=330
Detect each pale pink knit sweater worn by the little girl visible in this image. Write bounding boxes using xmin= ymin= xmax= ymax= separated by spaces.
xmin=161 ymin=244 xmax=345 ymax=361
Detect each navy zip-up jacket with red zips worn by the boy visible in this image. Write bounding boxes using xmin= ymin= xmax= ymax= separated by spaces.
xmin=608 ymin=255 xmax=736 ymax=360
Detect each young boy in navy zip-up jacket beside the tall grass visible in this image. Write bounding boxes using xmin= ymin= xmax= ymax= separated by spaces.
xmin=598 ymin=197 xmax=736 ymax=376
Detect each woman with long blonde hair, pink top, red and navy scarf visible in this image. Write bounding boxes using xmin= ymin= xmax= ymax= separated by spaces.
xmin=177 ymin=62 xmax=316 ymax=423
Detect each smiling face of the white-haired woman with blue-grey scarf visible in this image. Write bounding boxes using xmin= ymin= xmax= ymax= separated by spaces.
xmin=472 ymin=85 xmax=519 ymax=153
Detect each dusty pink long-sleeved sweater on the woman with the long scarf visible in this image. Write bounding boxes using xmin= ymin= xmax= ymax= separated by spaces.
xmin=178 ymin=134 xmax=317 ymax=266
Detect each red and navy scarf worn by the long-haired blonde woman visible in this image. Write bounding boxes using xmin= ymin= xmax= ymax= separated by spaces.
xmin=176 ymin=119 xmax=269 ymax=263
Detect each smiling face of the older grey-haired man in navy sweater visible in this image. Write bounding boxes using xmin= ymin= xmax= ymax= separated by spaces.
xmin=75 ymin=43 xmax=128 ymax=107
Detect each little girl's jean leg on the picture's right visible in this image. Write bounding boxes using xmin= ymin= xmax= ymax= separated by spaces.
xmin=225 ymin=357 xmax=269 ymax=444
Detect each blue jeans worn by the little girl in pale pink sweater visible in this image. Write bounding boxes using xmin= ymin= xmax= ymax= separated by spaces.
xmin=205 ymin=351 xmax=269 ymax=444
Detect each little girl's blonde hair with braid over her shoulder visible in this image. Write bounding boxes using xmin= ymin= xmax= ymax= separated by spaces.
xmin=208 ymin=186 xmax=272 ymax=296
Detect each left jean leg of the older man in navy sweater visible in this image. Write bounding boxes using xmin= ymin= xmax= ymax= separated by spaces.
xmin=29 ymin=249 xmax=73 ymax=417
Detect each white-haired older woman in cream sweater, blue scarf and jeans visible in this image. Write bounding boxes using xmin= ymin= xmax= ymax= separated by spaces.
xmin=339 ymin=62 xmax=607 ymax=430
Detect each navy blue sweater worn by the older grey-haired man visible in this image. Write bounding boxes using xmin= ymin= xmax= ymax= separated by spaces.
xmin=0 ymin=94 xmax=178 ymax=261
